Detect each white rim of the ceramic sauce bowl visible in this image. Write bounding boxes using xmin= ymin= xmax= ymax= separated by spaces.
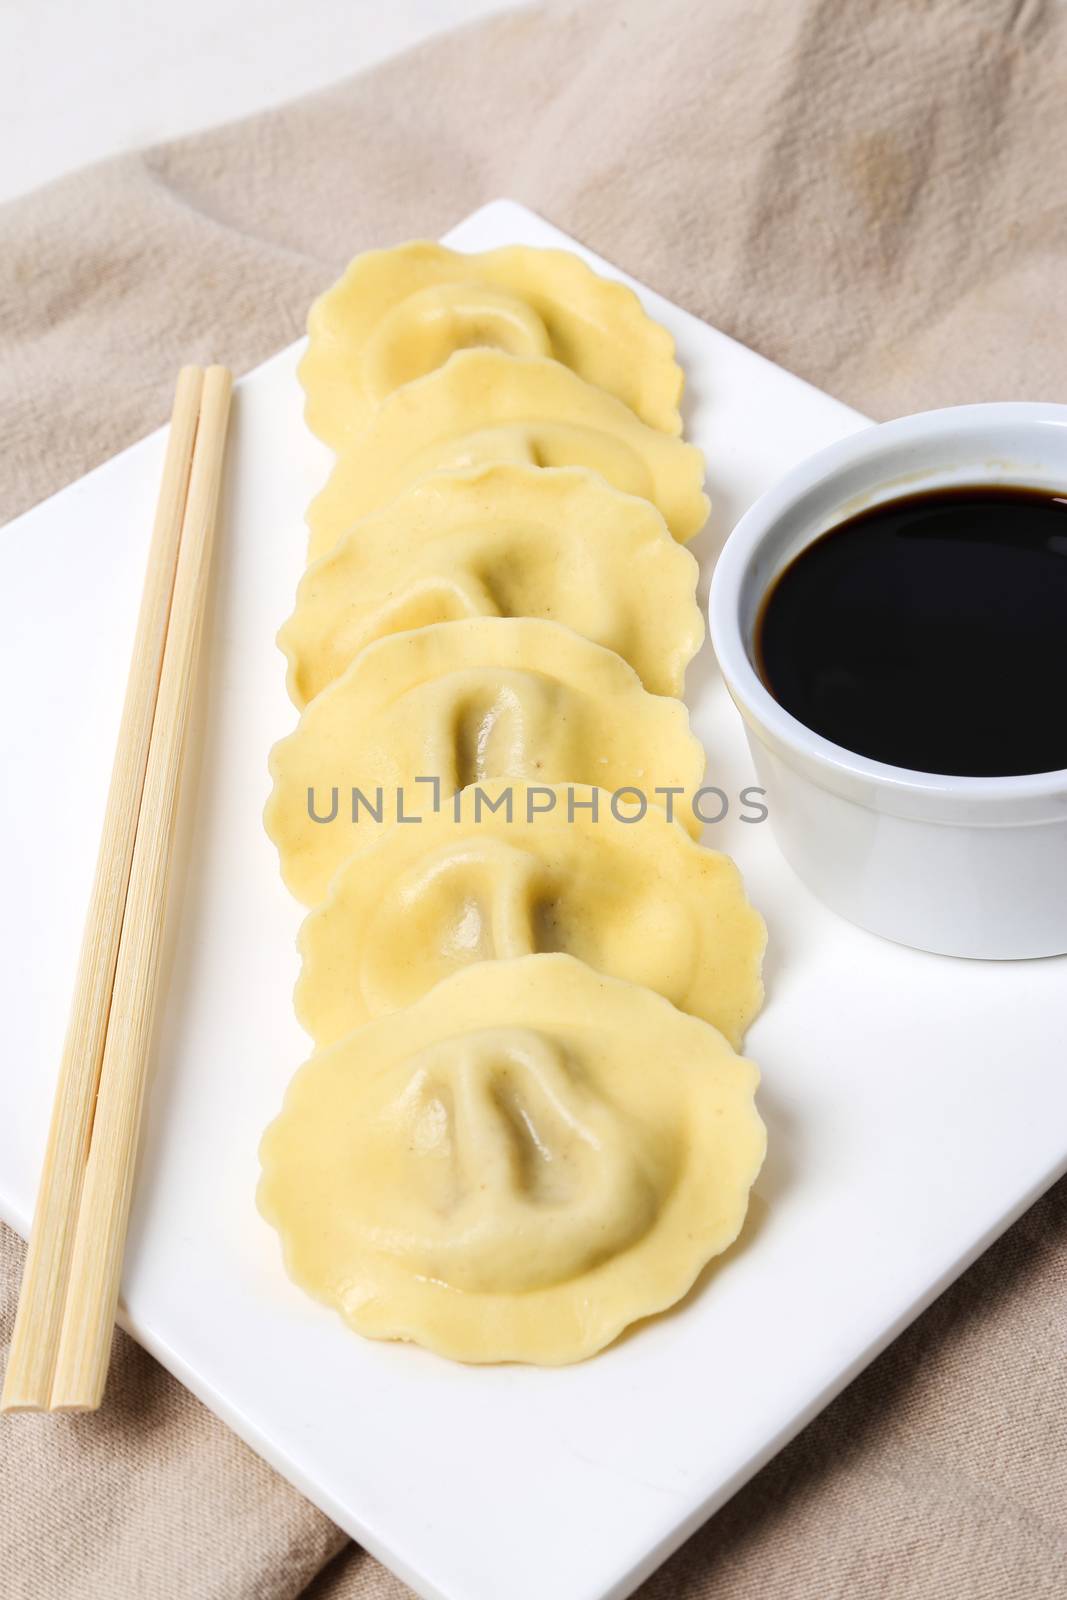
xmin=709 ymin=400 xmax=1067 ymax=810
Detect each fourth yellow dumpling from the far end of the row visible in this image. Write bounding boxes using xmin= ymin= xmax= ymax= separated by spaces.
xmin=264 ymin=618 xmax=704 ymax=906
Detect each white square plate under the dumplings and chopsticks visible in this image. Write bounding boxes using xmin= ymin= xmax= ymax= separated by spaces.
xmin=0 ymin=202 xmax=1067 ymax=1600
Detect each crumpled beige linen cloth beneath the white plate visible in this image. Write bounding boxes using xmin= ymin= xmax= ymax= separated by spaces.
xmin=0 ymin=0 xmax=1067 ymax=1600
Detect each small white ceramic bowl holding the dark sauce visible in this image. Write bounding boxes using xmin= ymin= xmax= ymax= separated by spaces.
xmin=710 ymin=403 xmax=1067 ymax=960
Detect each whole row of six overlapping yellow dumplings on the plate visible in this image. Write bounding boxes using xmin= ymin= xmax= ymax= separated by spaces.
xmin=259 ymin=243 xmax=765 ymax=1365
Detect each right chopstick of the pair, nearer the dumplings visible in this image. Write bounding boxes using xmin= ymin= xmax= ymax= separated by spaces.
xmin=51 ymin=366 xmax=230 ymax=1411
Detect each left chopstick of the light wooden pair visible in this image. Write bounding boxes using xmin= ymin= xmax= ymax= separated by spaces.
xmin=0 ymin=366 xmax=203 ymax=1411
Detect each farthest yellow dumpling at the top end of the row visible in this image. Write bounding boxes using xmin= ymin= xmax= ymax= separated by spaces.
xmin=301 ymin=233 xmax=683 ymax=450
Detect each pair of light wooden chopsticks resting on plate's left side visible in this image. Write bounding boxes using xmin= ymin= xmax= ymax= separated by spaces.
xmin=0 ymin=366 xmax=230 ymax=1411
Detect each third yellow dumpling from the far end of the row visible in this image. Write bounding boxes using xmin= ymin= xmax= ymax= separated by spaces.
xmin=278 ymin=464 xmax=704 ymax=707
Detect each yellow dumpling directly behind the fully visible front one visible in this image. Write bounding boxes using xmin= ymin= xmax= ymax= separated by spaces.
xmin=296 ymin=782 xmax=766 ymax=1048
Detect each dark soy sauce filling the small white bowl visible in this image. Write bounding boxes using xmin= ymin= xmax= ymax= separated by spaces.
xmin=755 ymin=485 xmax=1067 ymax=778
